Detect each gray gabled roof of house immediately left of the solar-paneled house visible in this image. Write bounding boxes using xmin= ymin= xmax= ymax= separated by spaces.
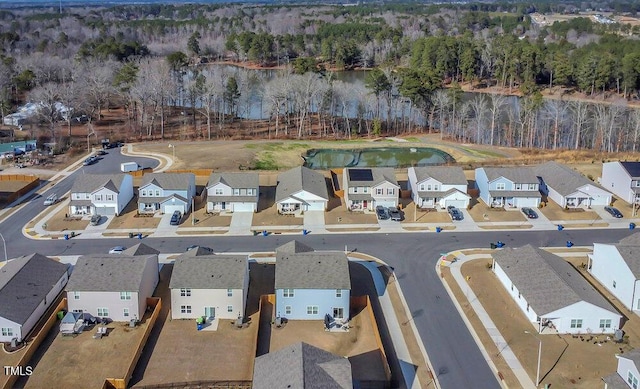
xmin=276 ymin=166 xmax=329 ymax=202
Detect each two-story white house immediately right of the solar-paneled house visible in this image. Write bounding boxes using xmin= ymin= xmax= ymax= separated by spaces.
xmin=408 ymin=166 xmax=471 ymax=209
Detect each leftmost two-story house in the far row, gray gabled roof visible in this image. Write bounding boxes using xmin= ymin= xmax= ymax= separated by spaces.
xmin=69 ymin=173 xmax=133 ymax=215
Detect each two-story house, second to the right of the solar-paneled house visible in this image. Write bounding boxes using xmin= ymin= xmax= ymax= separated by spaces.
xmin=475 ymin=167 xmax=542 ymax=208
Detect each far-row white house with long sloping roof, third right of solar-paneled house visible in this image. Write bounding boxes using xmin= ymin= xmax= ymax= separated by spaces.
xmin=533 ymin=162 xmax=612 ymax=208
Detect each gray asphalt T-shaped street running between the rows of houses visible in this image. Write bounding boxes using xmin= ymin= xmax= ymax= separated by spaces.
xmin=0 ymin=149 xmax=630 ymax=389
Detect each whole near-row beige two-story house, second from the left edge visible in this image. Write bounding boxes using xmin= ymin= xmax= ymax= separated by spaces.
xmin=66 ymin=254 xmax=159 ymax=321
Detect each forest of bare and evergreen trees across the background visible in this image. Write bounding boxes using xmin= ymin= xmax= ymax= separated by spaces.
xmin=0 ymin=1 xmax=640 ymax=151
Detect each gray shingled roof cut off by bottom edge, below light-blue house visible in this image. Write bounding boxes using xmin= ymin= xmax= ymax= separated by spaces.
xmin=253 ymin=342 xmax=353 ymax=389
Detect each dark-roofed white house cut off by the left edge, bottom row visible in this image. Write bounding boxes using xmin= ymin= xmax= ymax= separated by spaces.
xmin=0 ymin=254 xmax=69 ymax=342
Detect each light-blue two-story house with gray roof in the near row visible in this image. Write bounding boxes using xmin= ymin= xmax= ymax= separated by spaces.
xmin=275 ymin=242 xmax=351 ymax=321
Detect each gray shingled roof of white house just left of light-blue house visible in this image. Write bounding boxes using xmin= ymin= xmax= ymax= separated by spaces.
xmin=169 ymin=255 xmax=249 ymax=289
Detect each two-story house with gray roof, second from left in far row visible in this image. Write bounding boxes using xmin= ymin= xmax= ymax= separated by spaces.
xmin=138 ymin=173 xmax=196 ymax=215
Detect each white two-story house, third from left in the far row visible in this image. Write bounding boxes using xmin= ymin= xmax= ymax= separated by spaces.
xmin=207 ymin=173 xmax=260 ymax=212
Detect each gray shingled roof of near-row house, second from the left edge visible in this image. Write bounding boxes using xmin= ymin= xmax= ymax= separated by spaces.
xmin=66 ymin=254 xmax=158 ymax=292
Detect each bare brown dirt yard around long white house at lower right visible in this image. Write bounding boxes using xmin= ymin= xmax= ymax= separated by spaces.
xmin=462 ymin=258 xmax=637 ymax=389
